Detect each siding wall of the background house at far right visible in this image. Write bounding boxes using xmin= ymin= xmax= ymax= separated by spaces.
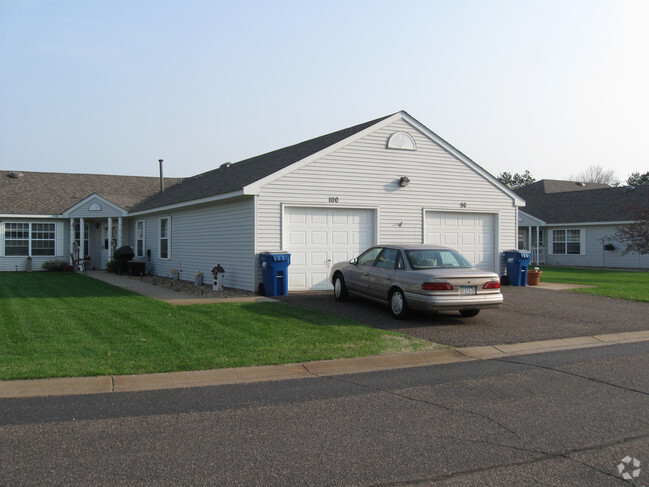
xmin=544 ymin=225 xmax=649 ymax=269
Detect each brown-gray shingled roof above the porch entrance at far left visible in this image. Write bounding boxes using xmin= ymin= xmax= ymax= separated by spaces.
xmin=0 ymin=171 xmax=181 ymax=215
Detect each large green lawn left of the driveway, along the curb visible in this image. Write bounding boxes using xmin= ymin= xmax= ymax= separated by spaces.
xmin=0 ymin=272 xmax=435 ymax=379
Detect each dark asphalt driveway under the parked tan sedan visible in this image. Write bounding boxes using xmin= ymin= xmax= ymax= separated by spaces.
xmin=278 ymin=286 xmax=649 ymax=347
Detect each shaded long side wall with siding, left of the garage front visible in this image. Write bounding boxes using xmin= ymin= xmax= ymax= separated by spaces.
xmin=129 ymin=197 xmax=256 ymax=291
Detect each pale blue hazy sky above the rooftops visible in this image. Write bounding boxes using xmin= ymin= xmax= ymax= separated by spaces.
xmin=0 ymin=0 xmax=649 ymax=180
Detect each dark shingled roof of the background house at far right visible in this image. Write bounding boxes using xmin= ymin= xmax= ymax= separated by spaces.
xmin=516 ymin=179 xmax=649 ymax=224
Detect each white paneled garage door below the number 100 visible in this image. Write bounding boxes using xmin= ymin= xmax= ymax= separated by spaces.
xmin=284 ymin=207 xmax=374 ymax=291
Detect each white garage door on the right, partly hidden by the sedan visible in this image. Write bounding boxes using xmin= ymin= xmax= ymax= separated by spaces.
xmin=425 ymin=211 xmax=496 ymax=272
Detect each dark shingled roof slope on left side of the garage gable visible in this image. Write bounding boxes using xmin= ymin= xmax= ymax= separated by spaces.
xmin=132 ymin=114 xmax=392 ymax=211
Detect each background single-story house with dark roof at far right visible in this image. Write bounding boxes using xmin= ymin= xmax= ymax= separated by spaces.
xmin=516 ymin=179 xmax=649 ymax=269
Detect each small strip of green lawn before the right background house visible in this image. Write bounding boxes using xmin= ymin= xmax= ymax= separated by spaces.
xmin=541 ymin=267 xmax=649 ymax=302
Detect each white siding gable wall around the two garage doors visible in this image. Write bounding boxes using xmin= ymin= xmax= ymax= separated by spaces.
xmin=257 ymin=120 xmax=517 ymax=274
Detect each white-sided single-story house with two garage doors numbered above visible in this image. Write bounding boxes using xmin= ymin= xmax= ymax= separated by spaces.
xmin=0 ymin=111 xmax=524 ymax=291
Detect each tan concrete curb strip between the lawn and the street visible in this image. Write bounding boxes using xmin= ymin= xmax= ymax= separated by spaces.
xmin=0 ymin=331 xmax=649 ymax=398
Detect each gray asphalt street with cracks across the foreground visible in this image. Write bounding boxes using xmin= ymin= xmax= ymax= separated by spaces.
xmin=0 ymin=342 xmax=649 ymax=486
